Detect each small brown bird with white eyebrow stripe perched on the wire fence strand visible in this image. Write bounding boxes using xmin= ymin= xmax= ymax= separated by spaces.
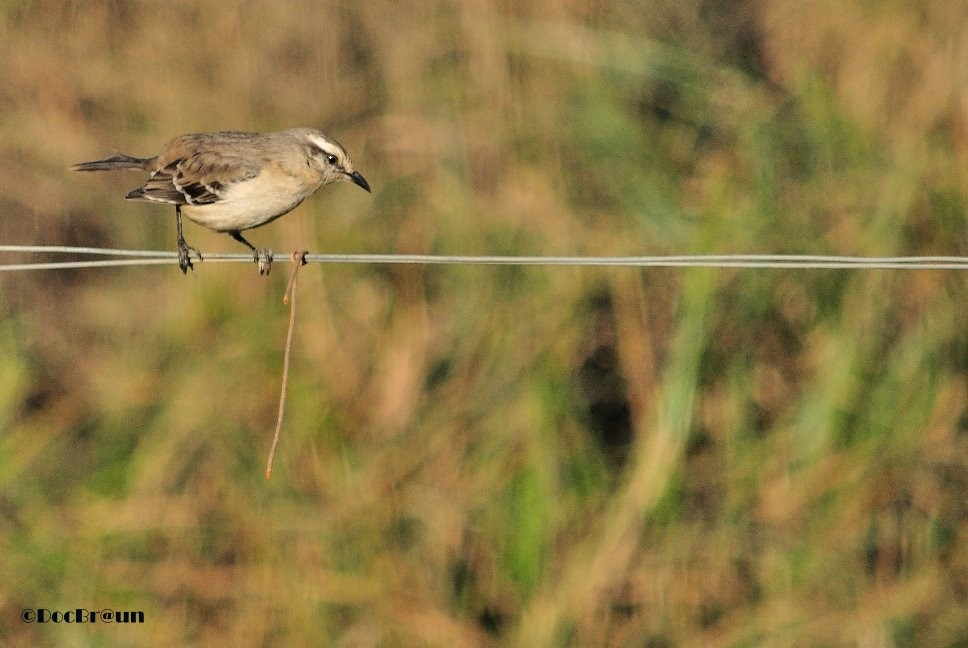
xmin=71 ymin=128 xmax=370 ymax=274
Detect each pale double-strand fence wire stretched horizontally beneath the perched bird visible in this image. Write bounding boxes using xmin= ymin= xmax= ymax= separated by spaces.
xmin=0 ymin=245 xmax=968 ymax=272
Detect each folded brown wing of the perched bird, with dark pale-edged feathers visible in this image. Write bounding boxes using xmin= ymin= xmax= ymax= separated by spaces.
xmin=125 ymin=144 xmax=260 ymax=205
